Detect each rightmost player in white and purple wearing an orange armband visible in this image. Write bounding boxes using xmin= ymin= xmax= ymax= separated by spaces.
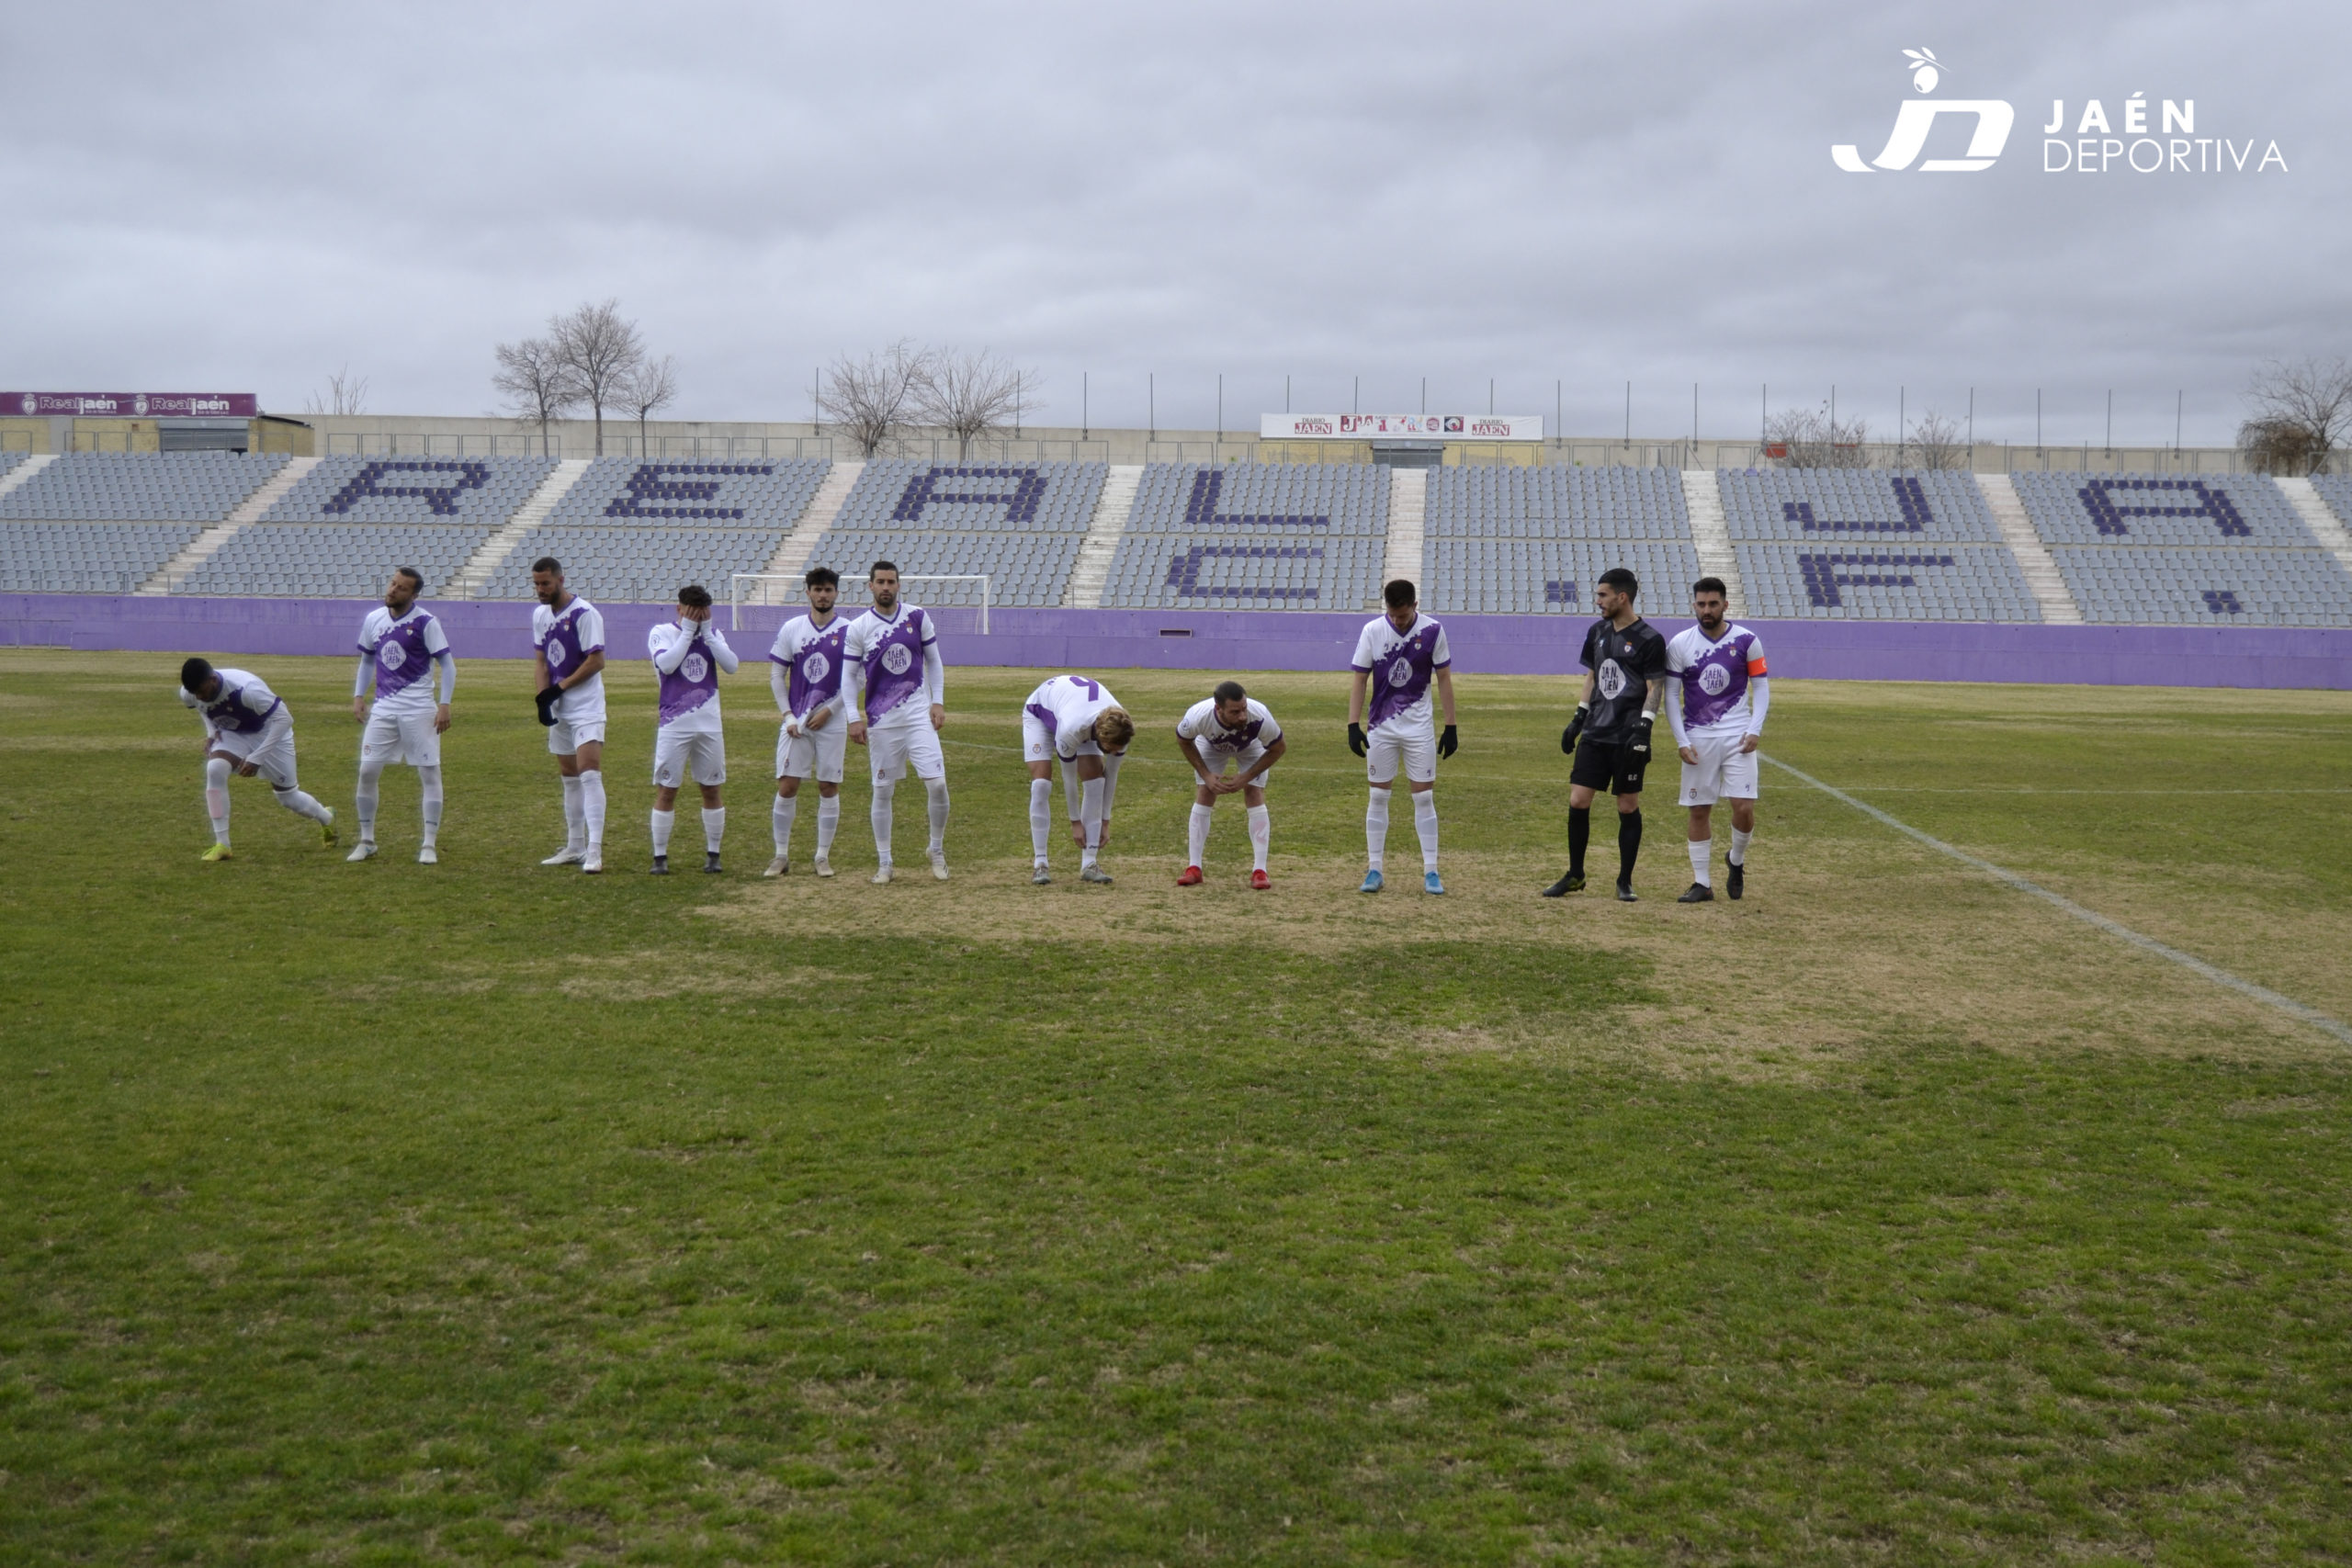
xmin=1665 ymin=576 xmax=1771 ymax=903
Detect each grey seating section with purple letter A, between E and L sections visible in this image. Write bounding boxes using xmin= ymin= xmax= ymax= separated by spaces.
xmin=804 ymin=458 xmax=1110 ymax=606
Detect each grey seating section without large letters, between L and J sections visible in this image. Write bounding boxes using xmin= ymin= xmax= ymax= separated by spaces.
xmin=1420 ymin=468 xmax=1701 ymax=616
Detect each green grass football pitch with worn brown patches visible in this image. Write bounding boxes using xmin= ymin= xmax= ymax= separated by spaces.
xmin=0 ymin=651 xmax=2352 ymax=1563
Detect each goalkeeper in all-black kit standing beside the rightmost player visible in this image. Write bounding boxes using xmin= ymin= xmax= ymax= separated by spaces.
xmin=1543 ymin=567 xmax=1665 ymax=903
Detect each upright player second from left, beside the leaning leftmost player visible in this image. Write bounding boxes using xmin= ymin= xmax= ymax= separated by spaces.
xmin=345 ymin=567 xmax=457 ymax=865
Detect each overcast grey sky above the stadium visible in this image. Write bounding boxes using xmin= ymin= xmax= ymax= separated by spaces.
xmin=0 ymin=0 xmax=2352 ymax=445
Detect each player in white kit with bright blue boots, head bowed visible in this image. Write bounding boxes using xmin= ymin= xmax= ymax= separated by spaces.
xmin=1348 ymin=579 xmax=1456 ymax=894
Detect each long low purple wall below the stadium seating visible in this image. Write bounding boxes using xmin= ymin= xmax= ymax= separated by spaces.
xmin=0 ymin=592 xmax=2352 ymax=694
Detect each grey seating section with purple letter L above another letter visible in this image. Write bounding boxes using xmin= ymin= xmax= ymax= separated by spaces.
xmin=1103 ymin=463 xmax=1387 ymax=609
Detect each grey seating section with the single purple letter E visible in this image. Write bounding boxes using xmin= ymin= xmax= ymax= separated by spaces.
xmin=482 ymin=458 xmax=828 ymax=602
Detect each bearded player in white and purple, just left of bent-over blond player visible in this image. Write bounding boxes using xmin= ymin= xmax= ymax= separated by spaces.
xmin=842 ymin=562 xmax=948 ymax=882
